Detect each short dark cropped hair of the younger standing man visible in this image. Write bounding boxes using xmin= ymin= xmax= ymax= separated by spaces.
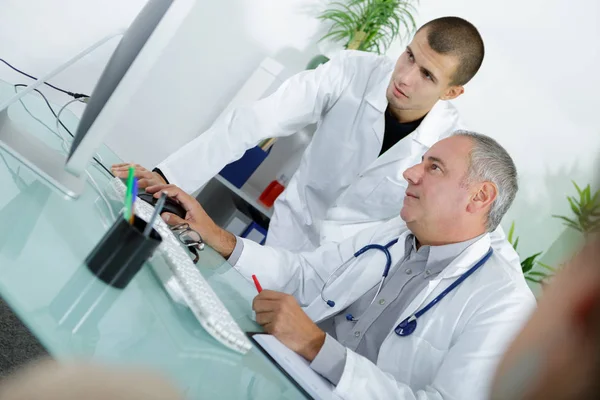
xmin=417 ymin=17 xmax=485 ymax=86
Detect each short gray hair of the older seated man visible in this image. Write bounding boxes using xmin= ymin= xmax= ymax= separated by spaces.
xmin=453 ymin=130 xmax=519 ymax=232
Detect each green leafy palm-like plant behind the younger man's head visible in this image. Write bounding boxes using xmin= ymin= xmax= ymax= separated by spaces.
xmin=307 ymin=0 xmax=416 ymax=69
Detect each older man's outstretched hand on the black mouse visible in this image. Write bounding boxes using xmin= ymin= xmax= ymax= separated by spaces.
xmin=146 ymin=185 xmax=236 ymax=258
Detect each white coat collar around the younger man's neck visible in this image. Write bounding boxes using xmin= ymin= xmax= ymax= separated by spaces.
xmin=365 ymin=64 xmax=460 ymax=147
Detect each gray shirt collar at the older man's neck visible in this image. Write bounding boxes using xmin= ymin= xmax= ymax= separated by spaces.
xmin=405 ymin=233 xmax=485 ymax=275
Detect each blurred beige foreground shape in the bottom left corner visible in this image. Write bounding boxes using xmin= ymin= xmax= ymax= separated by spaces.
xmin=0 ymin=360 xmax=183 ymax=400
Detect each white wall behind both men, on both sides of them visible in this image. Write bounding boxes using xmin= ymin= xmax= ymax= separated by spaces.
xmin=0 ymin=0 xmax=600 ymax=262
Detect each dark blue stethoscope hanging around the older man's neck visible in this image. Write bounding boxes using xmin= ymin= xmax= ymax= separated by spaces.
xmin=321 ymin=238 xmax=494 ymax=337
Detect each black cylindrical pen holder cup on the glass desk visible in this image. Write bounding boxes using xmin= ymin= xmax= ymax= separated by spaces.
xmin=85 ymin=215 xmax=162 ymax=289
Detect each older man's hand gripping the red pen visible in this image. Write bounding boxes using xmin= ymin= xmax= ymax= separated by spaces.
xmin=252 ymin=290 xmax=325 ymax=361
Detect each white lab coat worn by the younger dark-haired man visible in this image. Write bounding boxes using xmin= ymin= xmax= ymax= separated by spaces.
xmin=158 ymin=51 xmax=518 ymax=261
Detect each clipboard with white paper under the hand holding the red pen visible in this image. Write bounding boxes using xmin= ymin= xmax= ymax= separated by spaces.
xmin=246 ymin=332 xmax=336 ymax=400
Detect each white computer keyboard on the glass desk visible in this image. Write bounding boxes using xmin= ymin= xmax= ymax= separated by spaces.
xmin=111 ymin=178 xmax=252 ymax=354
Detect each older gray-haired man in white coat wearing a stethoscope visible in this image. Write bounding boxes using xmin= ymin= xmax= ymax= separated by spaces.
xmin=148 ymin=131 xmax=535 ymax=400
